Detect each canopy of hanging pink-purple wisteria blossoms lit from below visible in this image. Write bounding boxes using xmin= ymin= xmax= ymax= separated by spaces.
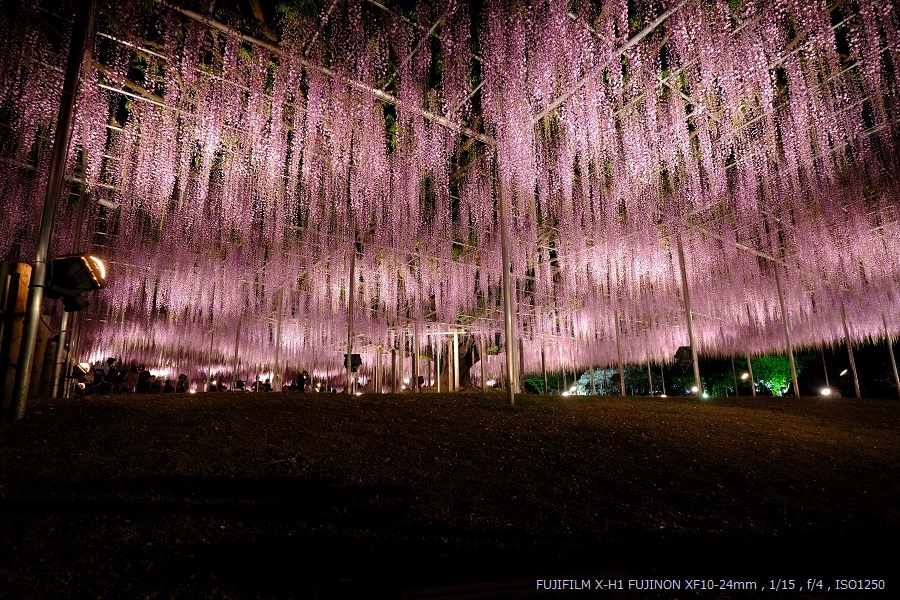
xmin=0 ymin=0 xmax=900 ymax=376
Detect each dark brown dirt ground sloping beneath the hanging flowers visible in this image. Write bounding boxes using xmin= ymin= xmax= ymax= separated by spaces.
xmin=0 ymin=393 xmax=900 ymax=599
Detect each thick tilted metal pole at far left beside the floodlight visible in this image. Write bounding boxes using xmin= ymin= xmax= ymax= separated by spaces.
xmin=10 ymin=0 xmax=94 ymax=420
